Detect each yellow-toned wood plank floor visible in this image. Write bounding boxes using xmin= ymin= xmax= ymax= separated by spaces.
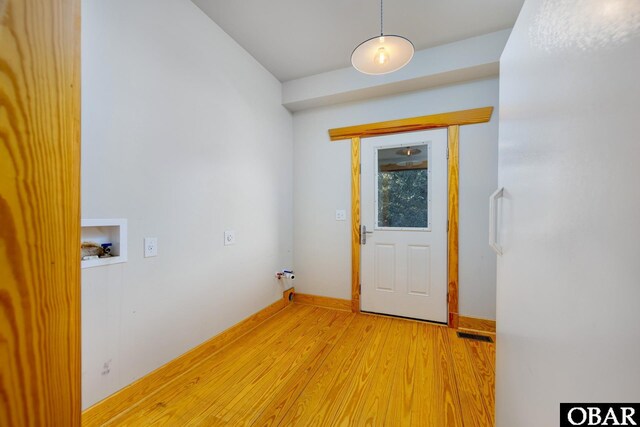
xmin=85 ymin=304 xmax=495 ymax=427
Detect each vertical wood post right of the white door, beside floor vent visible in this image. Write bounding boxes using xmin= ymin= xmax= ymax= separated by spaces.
xmin=448 ymin=125 xmax=460 ymax=328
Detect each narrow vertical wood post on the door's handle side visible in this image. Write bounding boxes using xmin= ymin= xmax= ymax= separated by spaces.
xmin=351 ymin=137 xmax=360 ymax=313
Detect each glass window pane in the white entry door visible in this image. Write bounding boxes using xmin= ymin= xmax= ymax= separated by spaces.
xmin=376 ymin=144 xmax=429 ymax=228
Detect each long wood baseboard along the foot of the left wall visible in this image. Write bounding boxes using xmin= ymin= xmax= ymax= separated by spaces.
xmin=78 ymin=300 xmax=288 ymax=425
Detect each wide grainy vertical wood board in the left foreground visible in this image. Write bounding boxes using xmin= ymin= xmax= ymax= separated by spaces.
xmin=0 ymin=0 xmax=81 ymax=427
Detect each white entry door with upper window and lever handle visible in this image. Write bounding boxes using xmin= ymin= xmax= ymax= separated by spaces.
xmin=360 ymin=129 xmax=447 ymax=323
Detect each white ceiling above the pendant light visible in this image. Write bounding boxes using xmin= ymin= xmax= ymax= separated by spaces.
xmin=193 ymin=0 xmax=524 ymax=82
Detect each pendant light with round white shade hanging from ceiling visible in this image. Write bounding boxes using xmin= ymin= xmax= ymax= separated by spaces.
xmin=351 ymin=0 xmax=415 ymax=75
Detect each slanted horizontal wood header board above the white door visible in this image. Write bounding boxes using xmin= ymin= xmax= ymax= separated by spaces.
xmin=329 ymin=107 xmax=493 ymax=141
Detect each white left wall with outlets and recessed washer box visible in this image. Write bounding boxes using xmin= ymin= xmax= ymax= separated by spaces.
xmin=82 ymin=0 xmax=292 ymax=407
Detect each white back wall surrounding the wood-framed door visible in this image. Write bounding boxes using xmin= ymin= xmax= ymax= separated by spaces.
xmin=293 ymin=79 xmax=498 ymax=319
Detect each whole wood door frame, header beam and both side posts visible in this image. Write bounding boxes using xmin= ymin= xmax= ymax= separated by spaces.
xmin=329 ymin=107 xmax=493 ymax=328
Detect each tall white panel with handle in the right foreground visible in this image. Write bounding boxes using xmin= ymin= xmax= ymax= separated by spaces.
xmin=496 ymin=0 xmax=640 ymax=427
